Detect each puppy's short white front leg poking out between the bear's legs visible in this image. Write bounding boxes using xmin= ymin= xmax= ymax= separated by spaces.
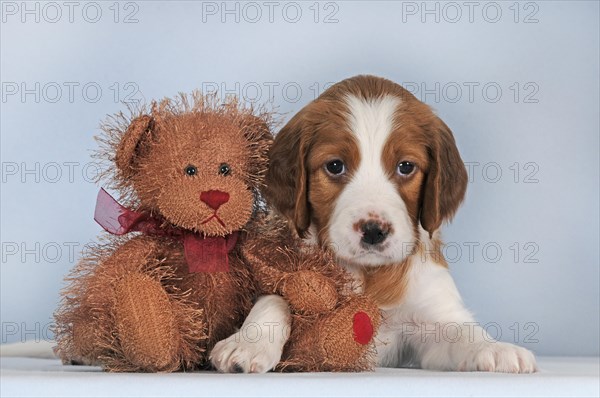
xmin=210 ymin=295 xmax=291 ymax=373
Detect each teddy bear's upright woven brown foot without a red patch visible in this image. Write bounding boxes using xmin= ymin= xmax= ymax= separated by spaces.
xmin=108 ymin=274 xmax=180 ymax=372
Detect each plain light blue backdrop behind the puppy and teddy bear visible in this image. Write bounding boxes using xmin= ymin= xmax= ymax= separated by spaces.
xmin=0 ymin=1 xmax=600 ymax=355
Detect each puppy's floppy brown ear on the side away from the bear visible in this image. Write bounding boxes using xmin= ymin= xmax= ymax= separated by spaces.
xmin=420 ymin=117 xmax=468 ymax=236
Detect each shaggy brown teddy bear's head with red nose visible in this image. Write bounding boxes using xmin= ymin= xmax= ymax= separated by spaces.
xmin=105 ymin=92 xmax=272 ymax=236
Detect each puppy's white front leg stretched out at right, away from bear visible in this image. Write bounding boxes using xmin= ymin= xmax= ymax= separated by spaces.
xmin=401 ymin=262 xmax=537 ymax=373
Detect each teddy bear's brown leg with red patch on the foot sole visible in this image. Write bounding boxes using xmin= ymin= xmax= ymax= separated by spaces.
xmin=280 ymin=297 xmax=381 ymax=371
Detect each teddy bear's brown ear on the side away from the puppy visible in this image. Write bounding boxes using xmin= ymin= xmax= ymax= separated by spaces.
xmin=115 ymin=115 xmax=155 ymax=178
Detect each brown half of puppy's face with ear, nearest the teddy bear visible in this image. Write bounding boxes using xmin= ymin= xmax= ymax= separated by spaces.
xmin=266 ymin=91 xmax=360 ymax=238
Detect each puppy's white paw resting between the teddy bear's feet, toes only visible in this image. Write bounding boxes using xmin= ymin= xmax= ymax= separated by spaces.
xmin=210 ymin=332 xmax=283 ymax=373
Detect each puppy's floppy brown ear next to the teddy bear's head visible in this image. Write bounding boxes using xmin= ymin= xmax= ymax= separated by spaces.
xmin=266 ymin=111 xmax=311 ymax=237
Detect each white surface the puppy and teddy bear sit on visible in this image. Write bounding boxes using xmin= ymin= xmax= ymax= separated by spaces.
xmin=0 ymin=357 xmax=600 ymax=397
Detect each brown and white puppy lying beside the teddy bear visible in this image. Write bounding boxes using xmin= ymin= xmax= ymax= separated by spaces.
xmin=213 ymin=76 xmax=536 ymax=373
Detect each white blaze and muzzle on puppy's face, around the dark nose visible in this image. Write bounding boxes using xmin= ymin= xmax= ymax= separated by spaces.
xmin=329 ymin=96 xmax=414 ymax=265
